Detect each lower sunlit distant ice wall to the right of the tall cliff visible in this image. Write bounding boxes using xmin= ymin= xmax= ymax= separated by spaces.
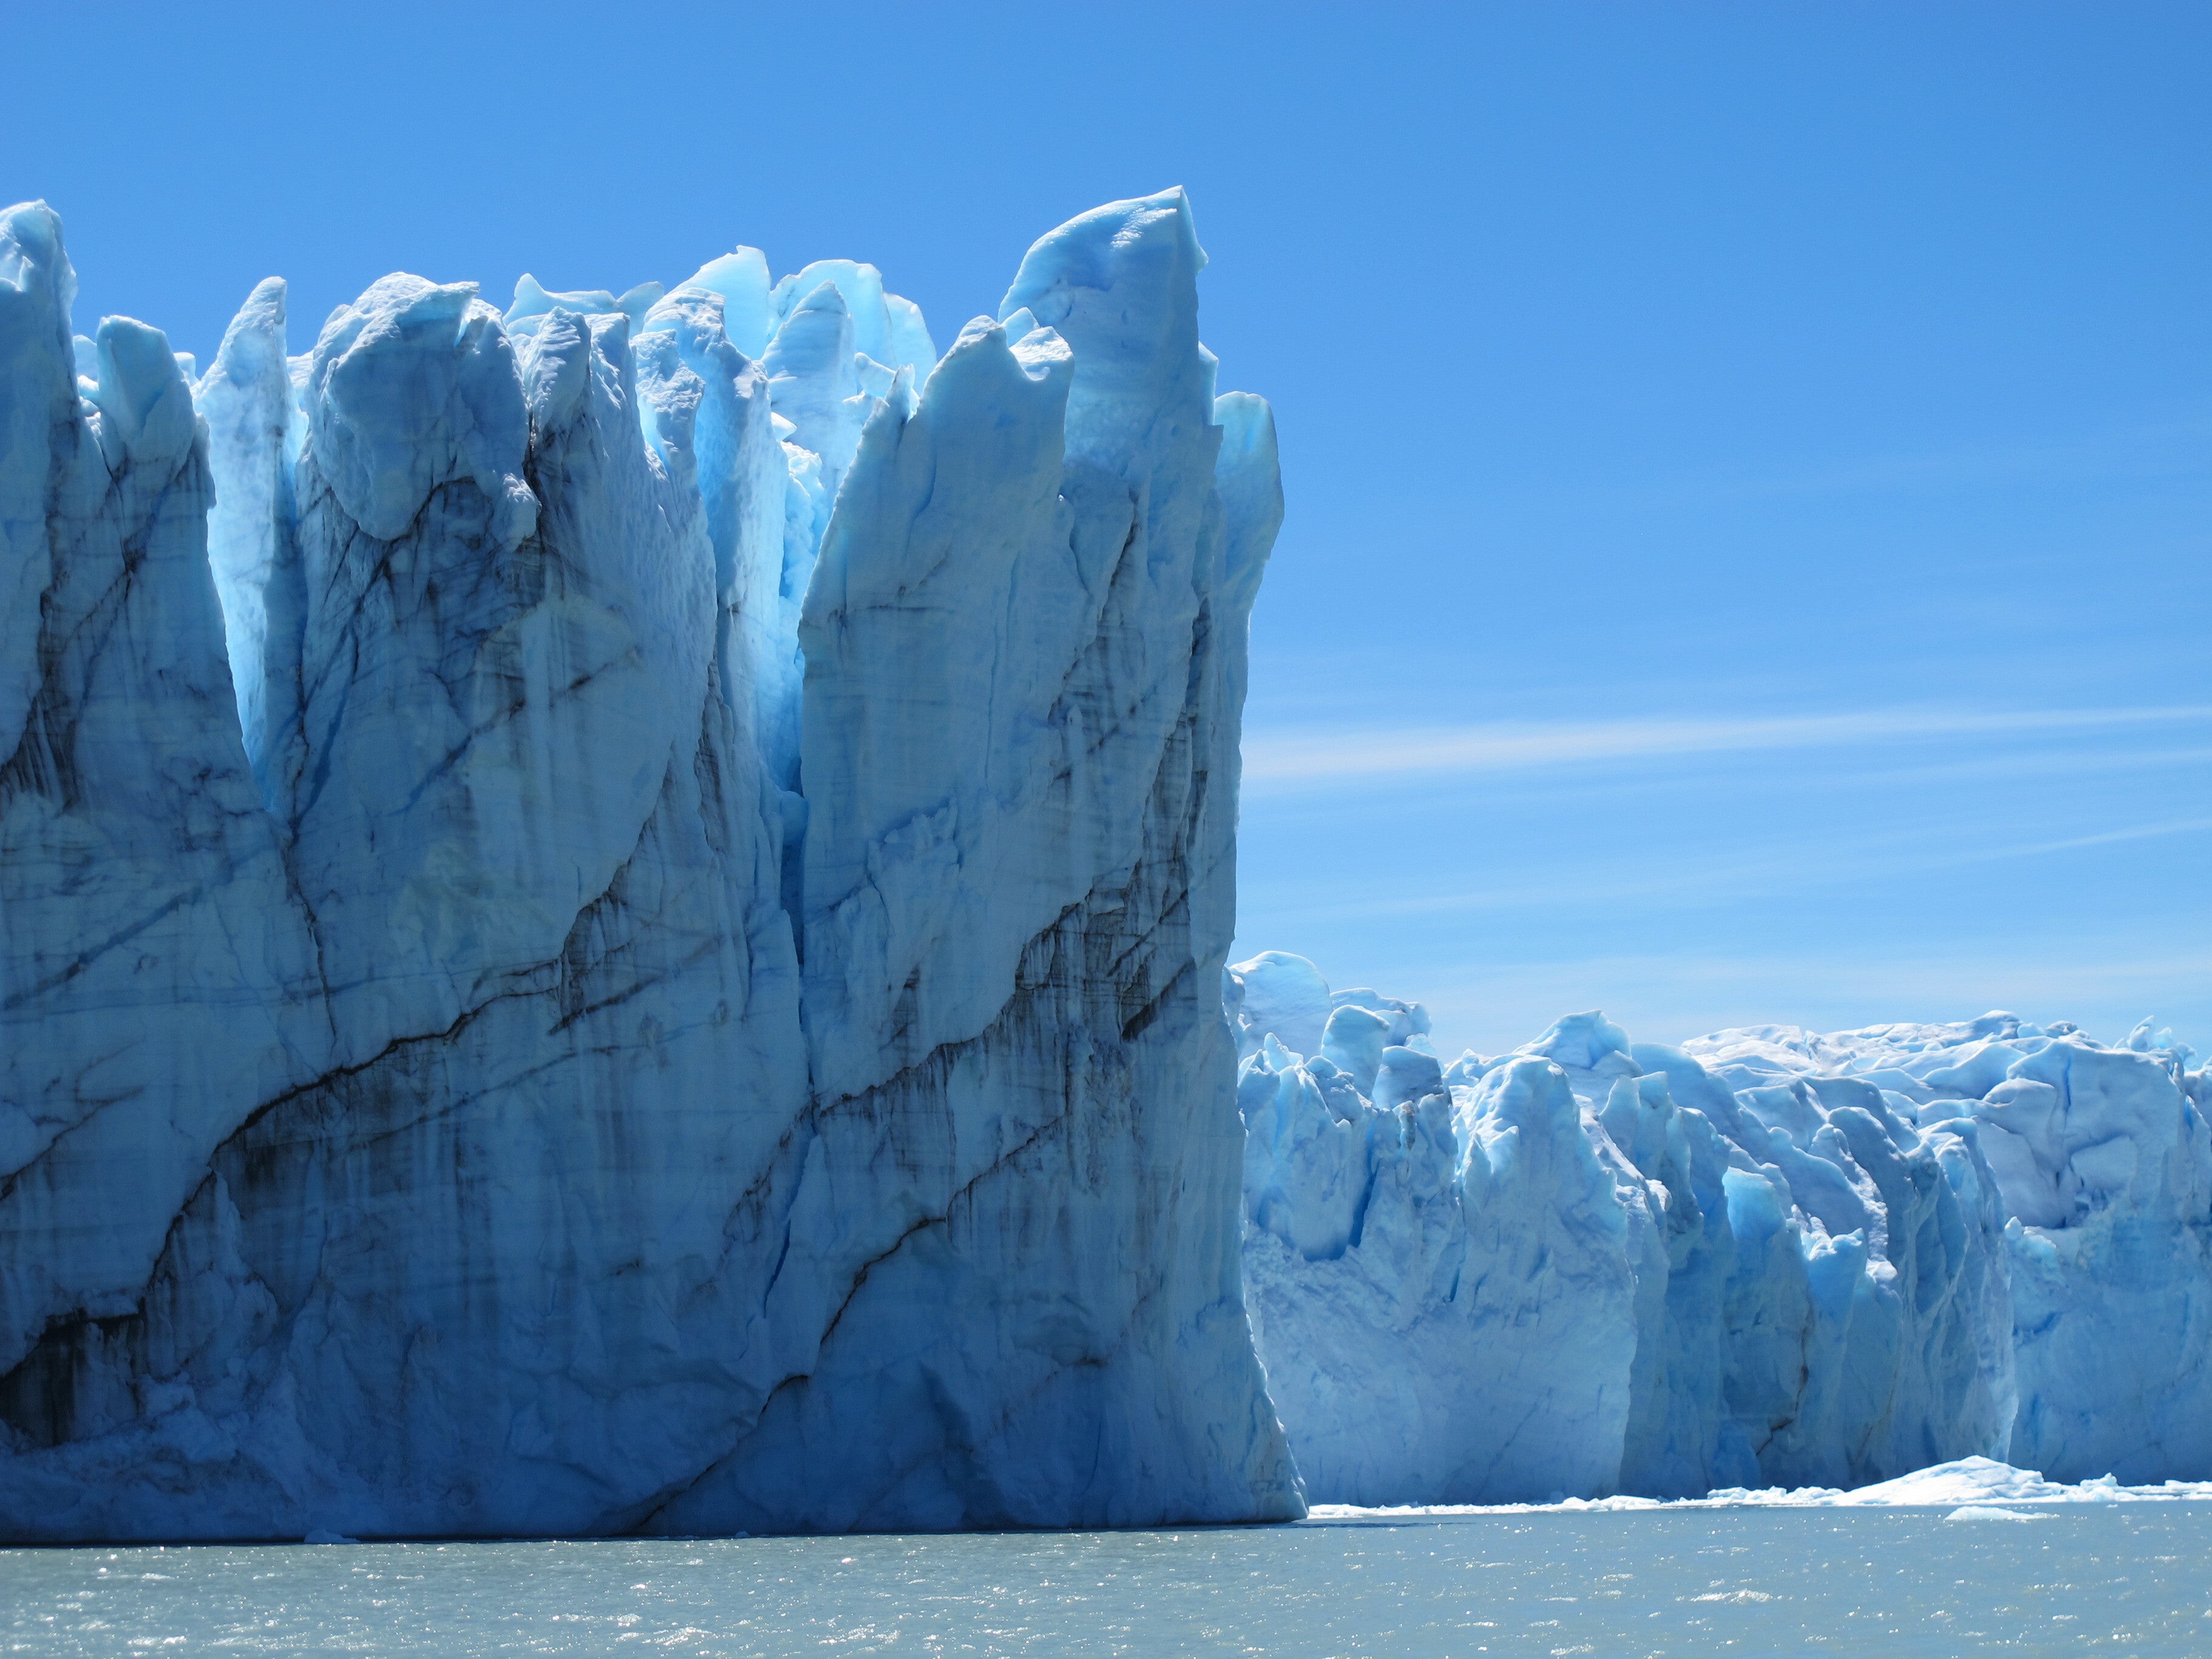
xmin=1225 ymin=951 xmax=2212 ymax=1504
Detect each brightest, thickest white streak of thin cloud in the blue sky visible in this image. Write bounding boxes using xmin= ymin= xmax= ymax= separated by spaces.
xmin=1243 ymin=703 xmax=2212 ymax=788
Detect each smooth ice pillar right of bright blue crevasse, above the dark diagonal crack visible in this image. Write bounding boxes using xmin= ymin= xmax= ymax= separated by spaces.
xmin=801 ymin=318 xmax=1074 ymax=1070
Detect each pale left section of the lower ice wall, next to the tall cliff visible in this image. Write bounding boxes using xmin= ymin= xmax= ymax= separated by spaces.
xmin=1239 ymin=1013 xmax=1648 ymax=1504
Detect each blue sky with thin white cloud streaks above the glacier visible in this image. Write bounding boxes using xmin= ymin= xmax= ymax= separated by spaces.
xmin=0 ymin=0 xmax=2212 ymax=1051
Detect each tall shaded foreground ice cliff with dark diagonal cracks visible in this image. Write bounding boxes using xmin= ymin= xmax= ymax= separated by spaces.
xmin=0 ymin=190 xmax=1301 ymax=1540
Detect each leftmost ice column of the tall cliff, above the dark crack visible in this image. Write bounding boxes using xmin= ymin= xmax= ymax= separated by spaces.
xmin=0 ymin=204 xmax=323 ymax=1451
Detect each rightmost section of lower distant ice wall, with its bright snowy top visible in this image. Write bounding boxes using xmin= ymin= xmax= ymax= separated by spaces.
xmin=1687 ymin=1013 xmax=2212 ymax=1482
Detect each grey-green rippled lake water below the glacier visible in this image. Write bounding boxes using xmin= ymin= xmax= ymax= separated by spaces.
xmin=0 ymin=1502 xmax=2212 ymax=1659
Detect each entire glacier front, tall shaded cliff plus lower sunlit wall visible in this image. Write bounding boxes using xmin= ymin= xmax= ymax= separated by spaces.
xmin=0 ymin=190 xmax=2212 ymax=1542
